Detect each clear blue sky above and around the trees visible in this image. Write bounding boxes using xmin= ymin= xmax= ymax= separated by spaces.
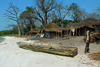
xmin=0 ymin=0 xmax=100 ymax=31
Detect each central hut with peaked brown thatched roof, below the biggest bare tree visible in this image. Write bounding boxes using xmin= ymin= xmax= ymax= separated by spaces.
xmin=43 ymin=22 xmax=63 ymax=38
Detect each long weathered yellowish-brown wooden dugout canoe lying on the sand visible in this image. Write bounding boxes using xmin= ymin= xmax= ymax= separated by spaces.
xmin=17 ymin=42 xmax=78 ymax=57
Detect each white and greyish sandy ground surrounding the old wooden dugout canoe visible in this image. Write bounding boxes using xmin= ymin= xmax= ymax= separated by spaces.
xmin=0 ymin=37 xmax=100 ymax=67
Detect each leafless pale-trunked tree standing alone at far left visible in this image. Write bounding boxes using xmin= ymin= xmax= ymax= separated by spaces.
xmin=4 ymin=3 xmax=21 ymax=36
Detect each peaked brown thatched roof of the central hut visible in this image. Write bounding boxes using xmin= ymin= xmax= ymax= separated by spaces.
xmin=43 ymin=22 xmax=63 ymax=32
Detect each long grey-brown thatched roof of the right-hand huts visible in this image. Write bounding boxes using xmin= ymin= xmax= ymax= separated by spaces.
xmin=65 ymin=20 xmax=100 ymax=30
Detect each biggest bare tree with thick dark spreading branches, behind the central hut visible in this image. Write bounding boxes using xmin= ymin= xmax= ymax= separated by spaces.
xmin=33 ymin=0 xmax=56 ymax=27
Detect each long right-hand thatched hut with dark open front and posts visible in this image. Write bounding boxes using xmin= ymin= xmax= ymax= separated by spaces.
xmin=65 ymin=20 xmax=100 ymax=36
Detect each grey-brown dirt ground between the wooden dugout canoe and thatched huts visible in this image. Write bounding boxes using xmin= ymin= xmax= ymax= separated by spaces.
xmin=27 ymin=36 xmax=100 ymax=55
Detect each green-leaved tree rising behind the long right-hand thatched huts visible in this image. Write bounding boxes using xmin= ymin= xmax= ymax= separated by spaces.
xmin=68 ymin=3 xmax=82 ymax=22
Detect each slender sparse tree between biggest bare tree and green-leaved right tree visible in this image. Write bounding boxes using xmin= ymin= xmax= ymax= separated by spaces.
xmin=56 ymin=3 xmax=68 ymax=27
